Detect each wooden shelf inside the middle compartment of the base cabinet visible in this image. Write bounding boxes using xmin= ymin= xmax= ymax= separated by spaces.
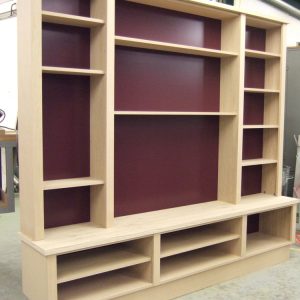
xmin=161 ymin=225 xmax=239 ymax=258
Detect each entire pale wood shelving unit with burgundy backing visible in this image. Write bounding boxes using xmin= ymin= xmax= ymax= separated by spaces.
xmin=18 ymin=0 xmax=297 ymax=300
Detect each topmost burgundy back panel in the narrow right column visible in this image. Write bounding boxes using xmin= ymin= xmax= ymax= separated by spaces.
xmin=246 ymin=26 xmax=266 ymax=51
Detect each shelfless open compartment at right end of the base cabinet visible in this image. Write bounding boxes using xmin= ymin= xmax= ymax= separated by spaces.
xmin=246 ymin=207 xmax=294 ymax=256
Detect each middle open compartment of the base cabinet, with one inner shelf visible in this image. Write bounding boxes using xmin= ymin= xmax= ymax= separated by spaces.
xmin=160 ymin=218 xmax=243 ymax=283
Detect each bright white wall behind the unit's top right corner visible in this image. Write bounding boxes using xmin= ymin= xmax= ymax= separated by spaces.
xmin=241 ymin=0 xmax=300 ymax=47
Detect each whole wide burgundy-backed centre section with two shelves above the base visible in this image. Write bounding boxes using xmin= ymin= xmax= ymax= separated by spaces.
xmin=114 ymin=1 xmax=242 ymax=217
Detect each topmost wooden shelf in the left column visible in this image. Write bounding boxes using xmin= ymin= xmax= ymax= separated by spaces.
xmin=42 ymin=10 xmax=104 ymax=28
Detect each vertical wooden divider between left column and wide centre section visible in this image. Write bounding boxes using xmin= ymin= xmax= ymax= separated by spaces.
xmin=90 ymin=0 xmax=115 ymax=227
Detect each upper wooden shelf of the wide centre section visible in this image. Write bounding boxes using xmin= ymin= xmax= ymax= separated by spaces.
xmin=115 ymin=36 xmax=237 ymax=58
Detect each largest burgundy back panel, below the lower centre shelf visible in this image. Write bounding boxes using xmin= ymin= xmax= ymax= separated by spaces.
xmin=115 ymin=116 xmax=219 ymax=216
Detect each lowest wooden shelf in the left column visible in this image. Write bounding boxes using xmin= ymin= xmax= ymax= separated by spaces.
xmin=44 ymin=177 xmax=104 ymax=191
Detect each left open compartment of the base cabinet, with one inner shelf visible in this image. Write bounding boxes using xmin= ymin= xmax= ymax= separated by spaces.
xmin=57 ymin=237 xmax=152 ymax=300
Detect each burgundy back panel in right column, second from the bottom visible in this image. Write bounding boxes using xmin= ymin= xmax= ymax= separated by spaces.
xmin=243 ymin=129 xmax=263 ymax=159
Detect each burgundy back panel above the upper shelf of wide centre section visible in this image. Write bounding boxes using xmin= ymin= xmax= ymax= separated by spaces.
xmin=116 ymin=0 xmax=221 ymax=49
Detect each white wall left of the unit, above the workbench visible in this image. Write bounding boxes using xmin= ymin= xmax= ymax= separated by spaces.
xmin=0 ymin=1 xmax=18 ymax=128
